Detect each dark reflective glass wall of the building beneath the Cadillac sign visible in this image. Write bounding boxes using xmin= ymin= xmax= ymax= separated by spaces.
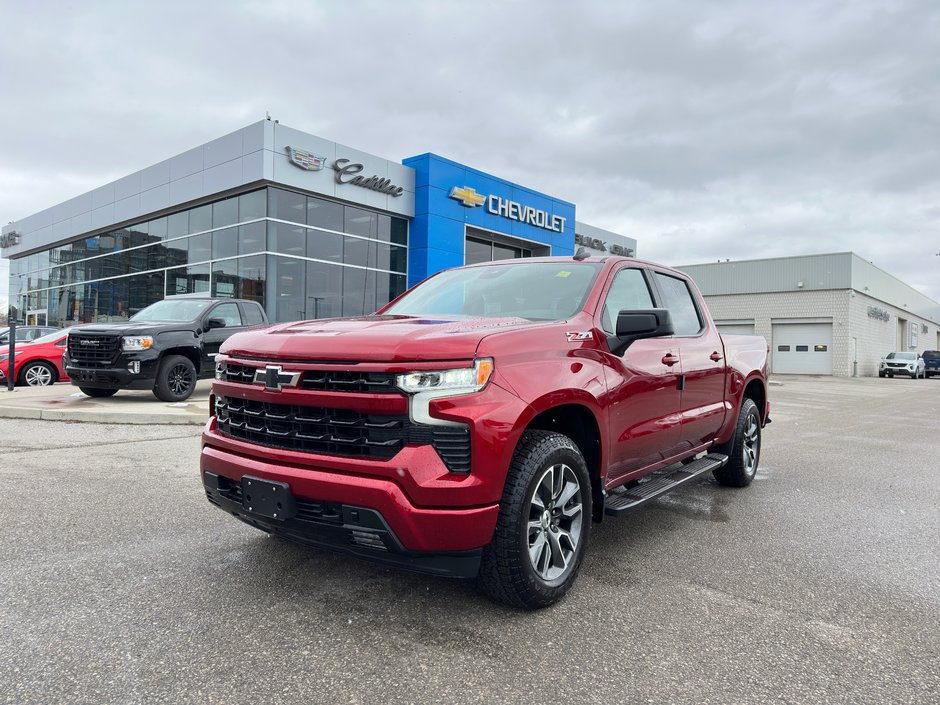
xmin=10 ymin=187 xmax=408 ymax=326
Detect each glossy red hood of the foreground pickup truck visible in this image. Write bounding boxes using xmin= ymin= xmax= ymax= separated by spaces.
xmin=221 ymin=316 xmax=544 ymax=362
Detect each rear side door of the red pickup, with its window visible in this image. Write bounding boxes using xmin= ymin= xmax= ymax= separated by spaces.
xmin=653 ymin=272 xmax=727 ymax=450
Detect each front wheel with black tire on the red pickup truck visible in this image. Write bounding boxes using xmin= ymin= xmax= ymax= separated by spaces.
xmin=480 ymin=431 xmax=592 ymax=609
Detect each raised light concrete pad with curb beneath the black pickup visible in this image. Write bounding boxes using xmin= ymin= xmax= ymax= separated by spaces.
xmin=0 ymin=379 xmax=212 ymax=425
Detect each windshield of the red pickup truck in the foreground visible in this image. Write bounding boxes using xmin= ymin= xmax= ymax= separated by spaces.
xmin=384 ymin=261 xmax=601 ymax=321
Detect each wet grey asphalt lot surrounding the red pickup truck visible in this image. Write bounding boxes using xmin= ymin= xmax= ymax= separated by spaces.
xmin=0 ymin=377 xmax=940 ymax=705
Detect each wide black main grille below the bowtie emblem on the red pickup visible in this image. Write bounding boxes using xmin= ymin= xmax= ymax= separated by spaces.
xmin=215 ymin=397 xmax=470 ymax=473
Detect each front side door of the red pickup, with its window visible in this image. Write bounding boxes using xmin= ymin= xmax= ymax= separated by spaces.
xmin=596 ymin=266 xmax=681 ymax=483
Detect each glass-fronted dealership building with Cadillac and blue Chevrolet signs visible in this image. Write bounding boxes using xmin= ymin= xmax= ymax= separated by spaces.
xmin=0 ymin=120 xmax=636 ymax=326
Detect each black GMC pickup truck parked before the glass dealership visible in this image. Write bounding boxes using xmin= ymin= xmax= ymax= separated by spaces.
xmin=63 ymin=296 xmax=268 ymax=402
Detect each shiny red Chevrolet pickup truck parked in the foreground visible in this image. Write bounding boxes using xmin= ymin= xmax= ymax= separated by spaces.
xmin=201 ymin=256 xmax=770 ymax=608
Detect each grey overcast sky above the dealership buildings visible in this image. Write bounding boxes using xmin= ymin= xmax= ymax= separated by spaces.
xmin=0 ymin=0 xmax=940 ymax=310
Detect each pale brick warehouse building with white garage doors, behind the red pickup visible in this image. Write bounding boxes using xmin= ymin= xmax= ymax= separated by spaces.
xmin=677 ymin=252 xmax=940 ymax=377
